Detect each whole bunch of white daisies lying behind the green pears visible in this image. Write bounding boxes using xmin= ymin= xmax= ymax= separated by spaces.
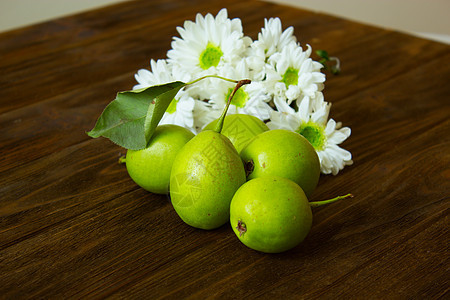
xmin=134 ymin=9 xmax=352 ymax=175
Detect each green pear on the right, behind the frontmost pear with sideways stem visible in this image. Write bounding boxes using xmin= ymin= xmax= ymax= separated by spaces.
xmin=240 ymin=129 xmax=320 ymax=197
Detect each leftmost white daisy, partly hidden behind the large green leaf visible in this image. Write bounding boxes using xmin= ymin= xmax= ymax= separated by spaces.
xmin=133 ymin=59 xmax=196 ymax=133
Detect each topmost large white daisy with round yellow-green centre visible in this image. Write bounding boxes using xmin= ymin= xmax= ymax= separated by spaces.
xmin=167 ymin=9 xmax=251 ymax=78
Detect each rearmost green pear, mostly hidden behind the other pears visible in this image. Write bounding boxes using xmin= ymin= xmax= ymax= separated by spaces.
xmin=203 ymin=114 xmax=269 ymax=153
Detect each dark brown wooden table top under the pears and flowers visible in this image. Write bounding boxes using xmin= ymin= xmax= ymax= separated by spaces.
xmin=0 ymin=0 xmax=450 ymax=299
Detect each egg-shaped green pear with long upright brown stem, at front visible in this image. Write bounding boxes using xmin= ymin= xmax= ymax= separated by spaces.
xmin=170 ymin=81 xmax=251 ymax=229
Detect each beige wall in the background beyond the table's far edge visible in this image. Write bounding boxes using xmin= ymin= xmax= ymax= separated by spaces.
xmin=0 ymin=0 xmax=450 ymax=43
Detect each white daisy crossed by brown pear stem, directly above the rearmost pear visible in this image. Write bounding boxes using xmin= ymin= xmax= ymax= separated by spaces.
xmin=210 ymin=60 xmax=273 ymax=120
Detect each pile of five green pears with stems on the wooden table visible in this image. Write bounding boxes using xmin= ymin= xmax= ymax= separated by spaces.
xmin=113 ymin=80 xmax=350 ymax=253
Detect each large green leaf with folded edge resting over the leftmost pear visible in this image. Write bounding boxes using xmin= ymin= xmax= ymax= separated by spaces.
xmin=87 ymin=81 xmax=186 ymax=150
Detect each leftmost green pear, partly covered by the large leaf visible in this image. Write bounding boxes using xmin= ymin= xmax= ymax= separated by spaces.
xmin=125 ymin=125 xmax=194 ymax=194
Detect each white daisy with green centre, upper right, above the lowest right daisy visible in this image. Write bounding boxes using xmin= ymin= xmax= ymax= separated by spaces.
xmin=266 ymin=43 xmax=325 ymax=110
